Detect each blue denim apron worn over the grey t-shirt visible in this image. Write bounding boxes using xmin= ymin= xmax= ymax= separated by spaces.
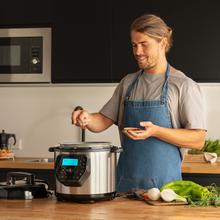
xmin=116 ymin=64 xmax=182 ymax=192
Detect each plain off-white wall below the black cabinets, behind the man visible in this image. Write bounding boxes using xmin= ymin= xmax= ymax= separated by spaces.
xmin=0 ymin=84 xmax=220 ymax=157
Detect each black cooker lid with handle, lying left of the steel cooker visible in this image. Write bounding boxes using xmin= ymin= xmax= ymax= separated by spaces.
xmin=0 ymin=172 xmax=50 ymax=199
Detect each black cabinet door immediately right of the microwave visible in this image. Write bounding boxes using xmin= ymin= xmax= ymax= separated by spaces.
xmin=52 ymin=0 xmax=111 ymax=83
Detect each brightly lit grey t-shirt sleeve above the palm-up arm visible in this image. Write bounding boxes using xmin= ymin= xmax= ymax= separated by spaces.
xmin=179 ymin=80 xmax=207 ymax=130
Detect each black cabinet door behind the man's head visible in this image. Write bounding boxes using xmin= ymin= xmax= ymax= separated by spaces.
xmin=112 ymin=0 xmax=220 ymax=82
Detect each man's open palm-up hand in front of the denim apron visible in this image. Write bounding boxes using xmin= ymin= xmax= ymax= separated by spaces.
xmin=122 ymin=121 xmax=157 ymax=140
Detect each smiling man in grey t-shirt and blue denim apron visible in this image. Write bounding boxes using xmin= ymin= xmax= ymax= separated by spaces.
xmin=72 ymin=15 xmax=206 ymax=192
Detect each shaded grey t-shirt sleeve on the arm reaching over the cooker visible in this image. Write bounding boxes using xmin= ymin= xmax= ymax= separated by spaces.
xmin=99 ymin=82 xmax=122 ymax=125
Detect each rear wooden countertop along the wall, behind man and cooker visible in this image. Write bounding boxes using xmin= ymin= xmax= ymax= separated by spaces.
xmin=0 ymin=158 xmax=220 ymax=174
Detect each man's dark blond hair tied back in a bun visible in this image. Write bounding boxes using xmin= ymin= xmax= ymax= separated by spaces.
xmin=130 ymin=14 xmax=173 ymax=52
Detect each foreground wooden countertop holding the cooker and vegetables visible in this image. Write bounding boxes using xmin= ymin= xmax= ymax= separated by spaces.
xmin=0 ymin=198 xmax=220 ymax=220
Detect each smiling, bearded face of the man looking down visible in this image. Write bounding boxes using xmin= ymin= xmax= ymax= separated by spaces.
xmin=131 ymin=31 xmax=165 ymax=71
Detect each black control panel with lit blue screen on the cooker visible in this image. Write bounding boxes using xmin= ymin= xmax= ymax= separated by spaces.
xmin=55 ymin=154 xmax=90 ymax=186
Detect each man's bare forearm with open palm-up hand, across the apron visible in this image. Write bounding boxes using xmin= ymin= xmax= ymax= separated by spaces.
xmin=123 ymin=122 xmax=206 ymax=149
